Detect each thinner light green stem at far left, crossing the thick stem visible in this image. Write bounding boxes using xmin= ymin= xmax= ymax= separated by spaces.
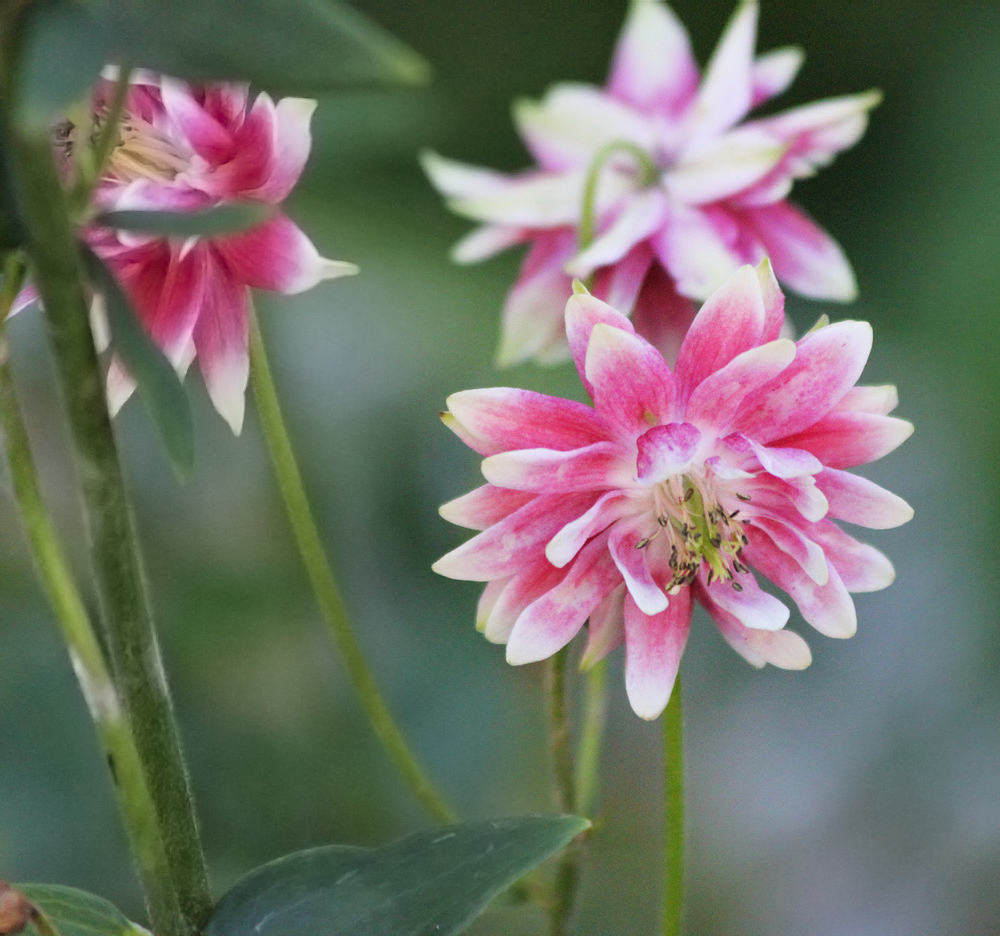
xmin=0 ymin=257 xmax=185 ymax=936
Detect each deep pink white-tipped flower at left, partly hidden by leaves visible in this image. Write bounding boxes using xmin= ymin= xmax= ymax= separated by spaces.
xmin=87 ymin=73 xmax=357 ymax=433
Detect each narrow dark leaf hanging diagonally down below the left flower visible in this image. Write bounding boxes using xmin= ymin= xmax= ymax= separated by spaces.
xmin=80 ymin=244 xmax=194 ymax=477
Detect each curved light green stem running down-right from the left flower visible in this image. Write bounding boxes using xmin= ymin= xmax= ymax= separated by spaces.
xmin=250 ymin=308 xmax=455 ymax=823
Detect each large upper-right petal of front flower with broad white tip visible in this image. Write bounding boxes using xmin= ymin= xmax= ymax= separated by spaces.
xmin=733 ymin=321 xmax=872 ymax=443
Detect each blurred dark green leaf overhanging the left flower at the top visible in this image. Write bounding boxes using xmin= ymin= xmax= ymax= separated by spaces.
xmin=104 ymin=0 xmax=429 ymax=97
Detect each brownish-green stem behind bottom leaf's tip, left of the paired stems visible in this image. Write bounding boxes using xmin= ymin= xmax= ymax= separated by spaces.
xmin=545 ymin=648 xmax=580 ymax=936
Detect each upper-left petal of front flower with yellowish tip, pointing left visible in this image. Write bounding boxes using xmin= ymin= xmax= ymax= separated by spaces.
xmin=448 ymin=387 xmax=608 ymax=455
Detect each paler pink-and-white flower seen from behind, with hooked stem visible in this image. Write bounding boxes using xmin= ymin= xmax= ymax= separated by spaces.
xmin=424 ymin=0 xmax=880 ymax=364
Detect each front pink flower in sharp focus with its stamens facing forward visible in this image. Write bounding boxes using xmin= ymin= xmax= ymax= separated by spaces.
xmin=434 ymin=262 xmax=913 ymax=718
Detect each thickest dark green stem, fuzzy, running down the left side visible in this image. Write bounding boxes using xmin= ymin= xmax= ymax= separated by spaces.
xmin=4 ymin=130 xmax=212 ymax=933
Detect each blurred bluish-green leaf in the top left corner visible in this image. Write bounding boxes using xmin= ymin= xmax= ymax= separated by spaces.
xmin=14 ymin=0 xmax=110 ymax=133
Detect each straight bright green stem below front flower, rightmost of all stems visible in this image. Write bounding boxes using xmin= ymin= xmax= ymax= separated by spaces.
xmin=663 ymin=675 xmax=684 ymax=936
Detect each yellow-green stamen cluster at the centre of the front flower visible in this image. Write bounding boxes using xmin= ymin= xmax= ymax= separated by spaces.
xmin=635 ymin=475 xmax=750 ymax=595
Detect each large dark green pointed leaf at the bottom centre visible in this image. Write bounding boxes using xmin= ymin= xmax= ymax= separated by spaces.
xmin=205 ymin=816 xmax=589 ymax=936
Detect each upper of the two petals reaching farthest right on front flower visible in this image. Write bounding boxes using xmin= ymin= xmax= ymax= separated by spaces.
xmin=778 ymin=411 xmax=913 ymax=468
